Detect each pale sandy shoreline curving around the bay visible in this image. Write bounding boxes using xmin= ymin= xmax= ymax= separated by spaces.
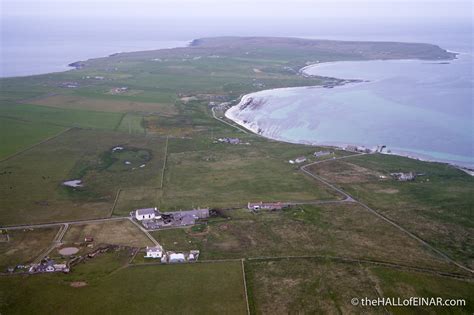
xmin=224 ymin=56 xmax=474 ymax=176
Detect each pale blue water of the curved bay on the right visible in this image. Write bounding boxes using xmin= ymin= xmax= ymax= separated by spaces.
xmin=227 ymin=53 xmax=474 ymax=167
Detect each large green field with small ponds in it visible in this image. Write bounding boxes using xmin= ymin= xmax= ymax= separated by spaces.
xmin=0 ymin=129 xmax=164 ymax=224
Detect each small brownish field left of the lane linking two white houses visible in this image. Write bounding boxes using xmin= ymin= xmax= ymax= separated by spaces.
xmin=63 ymin=220 xmax=153 ymax=247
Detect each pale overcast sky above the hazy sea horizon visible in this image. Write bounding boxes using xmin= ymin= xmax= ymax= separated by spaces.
xmin=1 ymin=0 xmax=474 ymax=19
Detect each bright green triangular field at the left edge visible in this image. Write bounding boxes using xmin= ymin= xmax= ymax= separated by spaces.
xmin=0 ymin=117 xmax=65 ymax=160
